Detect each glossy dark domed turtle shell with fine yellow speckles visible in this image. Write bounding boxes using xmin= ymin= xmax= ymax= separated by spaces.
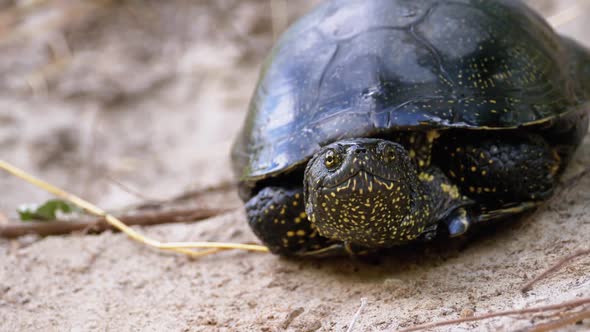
xmin=232 ymin=0 xmax=583 ymax=182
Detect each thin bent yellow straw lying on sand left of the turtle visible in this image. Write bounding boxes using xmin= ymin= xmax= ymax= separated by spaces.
xmin=0 ymin=159 xmax=268 ymax=257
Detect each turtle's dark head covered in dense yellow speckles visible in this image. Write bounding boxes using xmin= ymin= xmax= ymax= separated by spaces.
xmin=304 ymin=138 xmax=429 ymax=247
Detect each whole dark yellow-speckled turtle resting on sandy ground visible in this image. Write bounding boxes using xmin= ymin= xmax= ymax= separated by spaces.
xmin=231 ymin=0 xmax=590 ymax=257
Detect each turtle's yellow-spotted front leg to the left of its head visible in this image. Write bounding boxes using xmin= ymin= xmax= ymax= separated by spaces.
xmin=246 ymin=187 xmax=338 ymax=256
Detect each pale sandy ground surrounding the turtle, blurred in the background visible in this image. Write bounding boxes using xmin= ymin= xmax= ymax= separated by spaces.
xmin=0 ymin=0 xmax=590 ymax=331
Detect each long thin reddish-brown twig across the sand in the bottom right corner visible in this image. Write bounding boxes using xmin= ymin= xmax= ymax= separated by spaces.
xmin=399 ymin=298 xmax=590 ymax=332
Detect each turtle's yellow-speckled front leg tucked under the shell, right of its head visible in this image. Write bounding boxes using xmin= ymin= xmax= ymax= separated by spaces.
xmin=437 ymin=133 xmax=563 ymax=237
